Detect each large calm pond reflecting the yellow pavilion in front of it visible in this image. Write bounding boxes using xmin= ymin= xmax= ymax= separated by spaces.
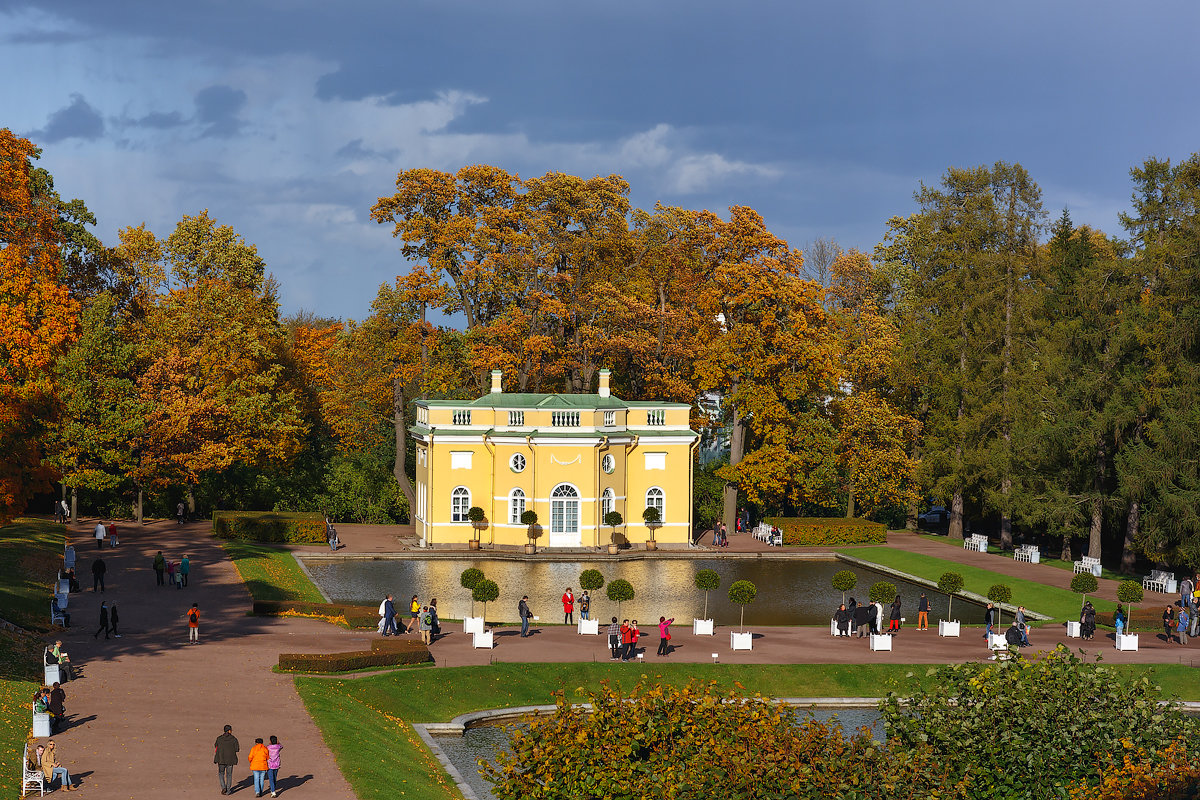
xmin=306 ymin=558 xmax=984 ymax=627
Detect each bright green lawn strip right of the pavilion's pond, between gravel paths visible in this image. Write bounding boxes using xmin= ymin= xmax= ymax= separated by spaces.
xmin=839 ymin=547 xmax=1116 ymax=620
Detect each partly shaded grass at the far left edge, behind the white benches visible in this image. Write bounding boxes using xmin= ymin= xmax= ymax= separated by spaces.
xmin=0 ymin=519 xmax=65 ymax=798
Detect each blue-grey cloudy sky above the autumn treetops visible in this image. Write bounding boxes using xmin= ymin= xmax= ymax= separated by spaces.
xmin=0 ymin=0 xmax=1200 ymax=319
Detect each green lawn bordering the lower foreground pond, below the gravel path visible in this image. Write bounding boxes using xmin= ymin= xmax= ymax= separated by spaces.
xmin=295 ymin=663 xmax=1200 ymax=800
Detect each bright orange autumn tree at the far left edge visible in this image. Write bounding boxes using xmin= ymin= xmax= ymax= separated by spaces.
xmin=0 ymin=128 xmax=79 ymax=522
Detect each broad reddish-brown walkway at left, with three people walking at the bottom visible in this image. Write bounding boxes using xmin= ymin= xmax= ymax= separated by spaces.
xmin=55 ymin=521 xmax=366 ymax=800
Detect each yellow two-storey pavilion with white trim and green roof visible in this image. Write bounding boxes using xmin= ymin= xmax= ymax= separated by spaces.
xmin=409 ymin=369 xmax=698 ymax=548
